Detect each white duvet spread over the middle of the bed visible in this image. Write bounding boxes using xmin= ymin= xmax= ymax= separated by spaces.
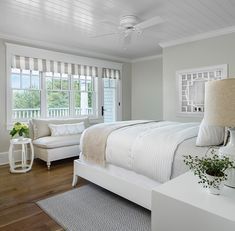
xmin=105 ymin=121 xmax=199 ymax=182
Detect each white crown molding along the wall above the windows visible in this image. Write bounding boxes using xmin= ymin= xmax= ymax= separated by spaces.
xmin=0 ymin=33 xmax=132 ymax=63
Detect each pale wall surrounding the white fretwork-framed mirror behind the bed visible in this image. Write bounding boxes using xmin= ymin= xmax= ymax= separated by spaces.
xmin=163 ymin=33 xmax=235 ymax=122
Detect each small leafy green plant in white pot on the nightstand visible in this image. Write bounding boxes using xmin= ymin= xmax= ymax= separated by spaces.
xmin=184 ymin=150 xmax=233 ymax=195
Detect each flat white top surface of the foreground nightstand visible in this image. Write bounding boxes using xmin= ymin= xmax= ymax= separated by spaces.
xmin=153 ymin=172 xmax=235 ymax=221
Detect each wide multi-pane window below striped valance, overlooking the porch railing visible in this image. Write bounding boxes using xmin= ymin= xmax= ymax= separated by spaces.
xmin=11 ymin=68 xmax=98 ymax=121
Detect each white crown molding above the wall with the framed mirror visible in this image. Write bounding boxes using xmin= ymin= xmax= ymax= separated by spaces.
xmin=159 ymin=26 xmax=235 ymax=48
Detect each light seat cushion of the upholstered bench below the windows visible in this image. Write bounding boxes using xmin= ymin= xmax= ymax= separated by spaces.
xmin=33 ymin=134 xmax=81 ymax=149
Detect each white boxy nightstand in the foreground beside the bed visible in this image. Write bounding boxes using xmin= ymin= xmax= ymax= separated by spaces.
xmin=151 ymin=172 xmax=235 ymax=231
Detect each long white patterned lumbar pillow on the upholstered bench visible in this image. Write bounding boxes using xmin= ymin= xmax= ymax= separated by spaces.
xmin=48 ymin=122 xmax=85 ymax=136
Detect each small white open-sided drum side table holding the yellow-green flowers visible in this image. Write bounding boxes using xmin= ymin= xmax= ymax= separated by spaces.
xmin=9 ymin=138 xmax=34 ymax=173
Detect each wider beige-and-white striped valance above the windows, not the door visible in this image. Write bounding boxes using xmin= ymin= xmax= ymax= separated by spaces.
xmin=11 ymin=55 xmax=98 ymax=77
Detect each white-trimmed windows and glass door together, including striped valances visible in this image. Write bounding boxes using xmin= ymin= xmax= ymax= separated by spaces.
xmin=6 ymin=43 xmax=121 ymax=128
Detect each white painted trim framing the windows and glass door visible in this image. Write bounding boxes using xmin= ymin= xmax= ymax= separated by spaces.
xmin=5 ymin=43 xmax=122 ymax=130
